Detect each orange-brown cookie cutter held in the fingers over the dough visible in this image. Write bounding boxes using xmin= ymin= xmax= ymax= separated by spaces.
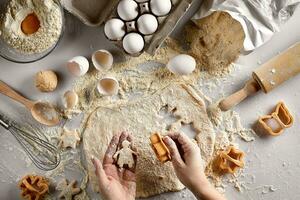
xmin=150 ymin=133 xmax=171 ymax=163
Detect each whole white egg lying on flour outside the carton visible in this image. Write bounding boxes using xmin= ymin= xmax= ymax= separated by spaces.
xmin=167 ymin=54 xmax=196 ymax=75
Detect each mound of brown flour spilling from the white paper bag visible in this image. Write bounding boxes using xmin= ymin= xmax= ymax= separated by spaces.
xmin=185 ymin=11 xmax=245 ymax=75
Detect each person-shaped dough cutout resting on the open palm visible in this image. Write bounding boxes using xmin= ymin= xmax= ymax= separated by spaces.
xmin=114 ymin=140 xmax=136 ymax=168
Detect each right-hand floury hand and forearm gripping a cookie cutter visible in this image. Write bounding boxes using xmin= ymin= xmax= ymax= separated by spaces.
xmin=163 ymin=133 xmax=225 ymax=200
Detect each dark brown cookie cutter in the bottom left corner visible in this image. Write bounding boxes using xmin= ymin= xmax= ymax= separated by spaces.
xmin=19 ymin=175 xmax=49 ymax=200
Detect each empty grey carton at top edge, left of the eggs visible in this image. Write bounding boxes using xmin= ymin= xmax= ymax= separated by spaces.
xmin=61 ymin=0 xmax=119 ymax=27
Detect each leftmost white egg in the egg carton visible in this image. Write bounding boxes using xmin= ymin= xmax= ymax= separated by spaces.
xmin=104 ymin=18 xmax=125 ymax=40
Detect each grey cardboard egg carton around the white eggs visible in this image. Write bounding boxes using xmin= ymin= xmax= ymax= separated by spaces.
xmin=105 ymin=0 xmax=193 ymax=56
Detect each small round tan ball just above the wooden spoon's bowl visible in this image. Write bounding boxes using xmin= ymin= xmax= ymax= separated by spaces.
xmin=35 ymin=70 xmax=58 ymax=92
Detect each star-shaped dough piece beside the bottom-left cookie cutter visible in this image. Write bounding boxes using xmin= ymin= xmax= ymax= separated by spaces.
xmin=56 ymin=179 xmax=81 ymax=200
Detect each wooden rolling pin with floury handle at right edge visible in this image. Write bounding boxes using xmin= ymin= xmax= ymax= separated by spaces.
xmin=219 ymin=42 xmax=300 ymax=111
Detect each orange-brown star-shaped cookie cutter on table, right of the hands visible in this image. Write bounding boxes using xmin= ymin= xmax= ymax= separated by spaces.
xmin=215 ymin=146 xmax=245 ymax=174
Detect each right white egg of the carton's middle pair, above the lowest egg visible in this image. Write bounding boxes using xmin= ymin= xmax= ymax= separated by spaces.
xmin=137 ymin=14 xmax=158 ymax=35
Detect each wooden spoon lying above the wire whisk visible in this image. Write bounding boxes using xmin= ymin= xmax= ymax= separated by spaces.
xmin=0 ymin=80 xmax=60 ymax=126
